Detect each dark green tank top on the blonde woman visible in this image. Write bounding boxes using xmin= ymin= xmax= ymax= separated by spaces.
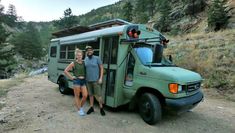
xmin=73 ymin=61 xmax=85 ymax=77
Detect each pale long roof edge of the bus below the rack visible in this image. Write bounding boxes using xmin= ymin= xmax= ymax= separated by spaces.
xmin=51 ymin=25 xmax=127 ymax=45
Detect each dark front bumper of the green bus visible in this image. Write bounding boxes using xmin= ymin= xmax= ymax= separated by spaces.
xmin=165 ymin=91 xmax=203 ymax=114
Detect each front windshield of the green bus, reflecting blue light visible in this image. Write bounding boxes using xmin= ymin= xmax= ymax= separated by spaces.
xmin=134 ymin=44 xmax=175 ymax=66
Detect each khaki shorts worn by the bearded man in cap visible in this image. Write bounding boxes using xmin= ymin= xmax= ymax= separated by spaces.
xmin=87 ymin=82 xmax=102 ymax=97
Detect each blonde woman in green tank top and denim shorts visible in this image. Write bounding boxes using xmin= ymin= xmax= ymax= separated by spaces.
xmin=64 ymin=49 xmax=88 ymax=116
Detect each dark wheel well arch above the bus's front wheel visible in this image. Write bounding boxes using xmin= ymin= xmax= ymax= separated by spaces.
xmin=135 ymin=87 xmax=166 ymax=106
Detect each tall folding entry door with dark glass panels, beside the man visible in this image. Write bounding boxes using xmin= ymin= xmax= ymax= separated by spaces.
xmin=103 ymin=36 xmax=119 ymax=107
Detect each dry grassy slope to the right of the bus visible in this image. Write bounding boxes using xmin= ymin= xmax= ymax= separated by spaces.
xmin=166 ymin=29 xmax=235 ymax=100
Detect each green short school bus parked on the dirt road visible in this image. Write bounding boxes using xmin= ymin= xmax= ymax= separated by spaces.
xmin=48 ymin=19 xmax=203 ymax=124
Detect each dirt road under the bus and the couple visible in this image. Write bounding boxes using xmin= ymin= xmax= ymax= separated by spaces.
xmin=0 ymin=75 xmax=235 ymax=133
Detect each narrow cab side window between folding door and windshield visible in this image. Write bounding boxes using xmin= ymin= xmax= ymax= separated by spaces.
xmin=125 ymin=54 xmax=135 ymax=86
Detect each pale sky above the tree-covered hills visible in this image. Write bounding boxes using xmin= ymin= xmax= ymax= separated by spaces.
xmin=0 ymin=0 xmax=119 ymax=22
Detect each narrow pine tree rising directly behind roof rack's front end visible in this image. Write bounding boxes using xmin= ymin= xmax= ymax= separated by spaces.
xmin=123 ymin=2 xmax=133 ymax=22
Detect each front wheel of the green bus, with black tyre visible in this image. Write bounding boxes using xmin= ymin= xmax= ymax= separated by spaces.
xmin=139 ymin=93 xmax=162 ymax=125
